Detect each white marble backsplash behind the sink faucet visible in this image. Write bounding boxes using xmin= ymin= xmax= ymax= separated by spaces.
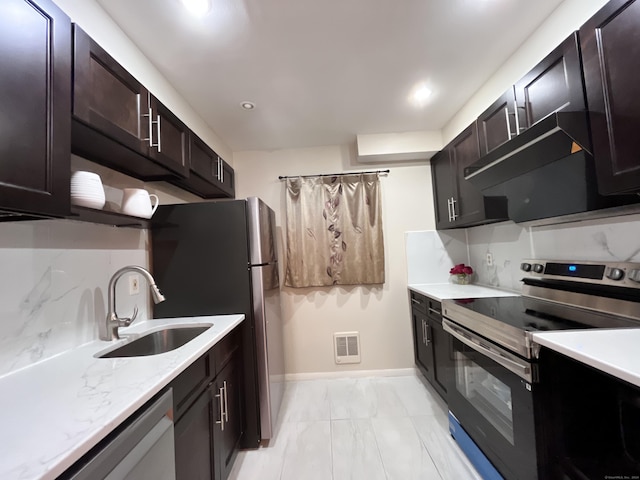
xmin=0 ymin=220 xmax=150 ymax=376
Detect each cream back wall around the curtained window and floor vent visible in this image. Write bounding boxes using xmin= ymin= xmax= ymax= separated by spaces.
xmin=235 ymin=146 xmax=434 ymax=375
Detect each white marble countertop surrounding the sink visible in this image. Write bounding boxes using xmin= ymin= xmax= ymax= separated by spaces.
xmin=0 ymin=315 xmax=244 ymax=480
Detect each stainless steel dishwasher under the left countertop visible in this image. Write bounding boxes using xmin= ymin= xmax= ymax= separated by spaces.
xmin=60 ymin=389 xmax=176 ymax=480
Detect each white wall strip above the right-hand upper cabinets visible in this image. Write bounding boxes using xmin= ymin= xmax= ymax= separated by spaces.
xmin=442 ymin=0 xmax=608 ymax=144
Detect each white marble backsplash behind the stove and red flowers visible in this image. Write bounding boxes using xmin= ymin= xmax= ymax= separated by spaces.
xmin=406 ymin=214 xmax=640 ymax=291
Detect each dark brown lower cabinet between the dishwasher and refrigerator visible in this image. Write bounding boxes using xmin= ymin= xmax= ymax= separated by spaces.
xmin=171 ymin=327 xmax=244 ymax=480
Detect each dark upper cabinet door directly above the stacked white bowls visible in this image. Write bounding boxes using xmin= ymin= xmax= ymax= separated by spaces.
xmin=73 ymin=25 xmax=149 ymax=155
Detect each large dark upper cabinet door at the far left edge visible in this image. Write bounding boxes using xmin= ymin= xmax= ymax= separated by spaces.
xmin=0 ymin=0 xmax=71 ymax=216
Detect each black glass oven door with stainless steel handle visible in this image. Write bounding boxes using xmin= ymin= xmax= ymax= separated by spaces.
xmin=442 ymin=319 xmax=538 ymax=479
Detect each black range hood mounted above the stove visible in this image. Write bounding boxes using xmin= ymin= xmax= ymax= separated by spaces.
xmin=464 ymin=111 xmax=640 ymax=222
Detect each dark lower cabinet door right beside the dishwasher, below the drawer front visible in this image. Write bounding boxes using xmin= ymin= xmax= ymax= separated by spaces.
xmin=174 ymin=389 xmax=216 ymax=480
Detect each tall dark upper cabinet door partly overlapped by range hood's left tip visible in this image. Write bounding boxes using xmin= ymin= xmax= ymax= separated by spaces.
xmin=448 ymin=122 xmax=485 ymax=225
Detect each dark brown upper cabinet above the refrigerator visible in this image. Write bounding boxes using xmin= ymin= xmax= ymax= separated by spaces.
xmin=172 ymin=132 xmax=235 ymax=198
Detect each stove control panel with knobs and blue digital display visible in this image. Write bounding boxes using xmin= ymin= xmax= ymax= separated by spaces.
xmin=520 ymin=260 xmax=640 ymax=289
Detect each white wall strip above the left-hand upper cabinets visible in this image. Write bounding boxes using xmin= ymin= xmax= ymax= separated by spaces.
xmin=54 ymin=0 xmax=233 ymax=165
